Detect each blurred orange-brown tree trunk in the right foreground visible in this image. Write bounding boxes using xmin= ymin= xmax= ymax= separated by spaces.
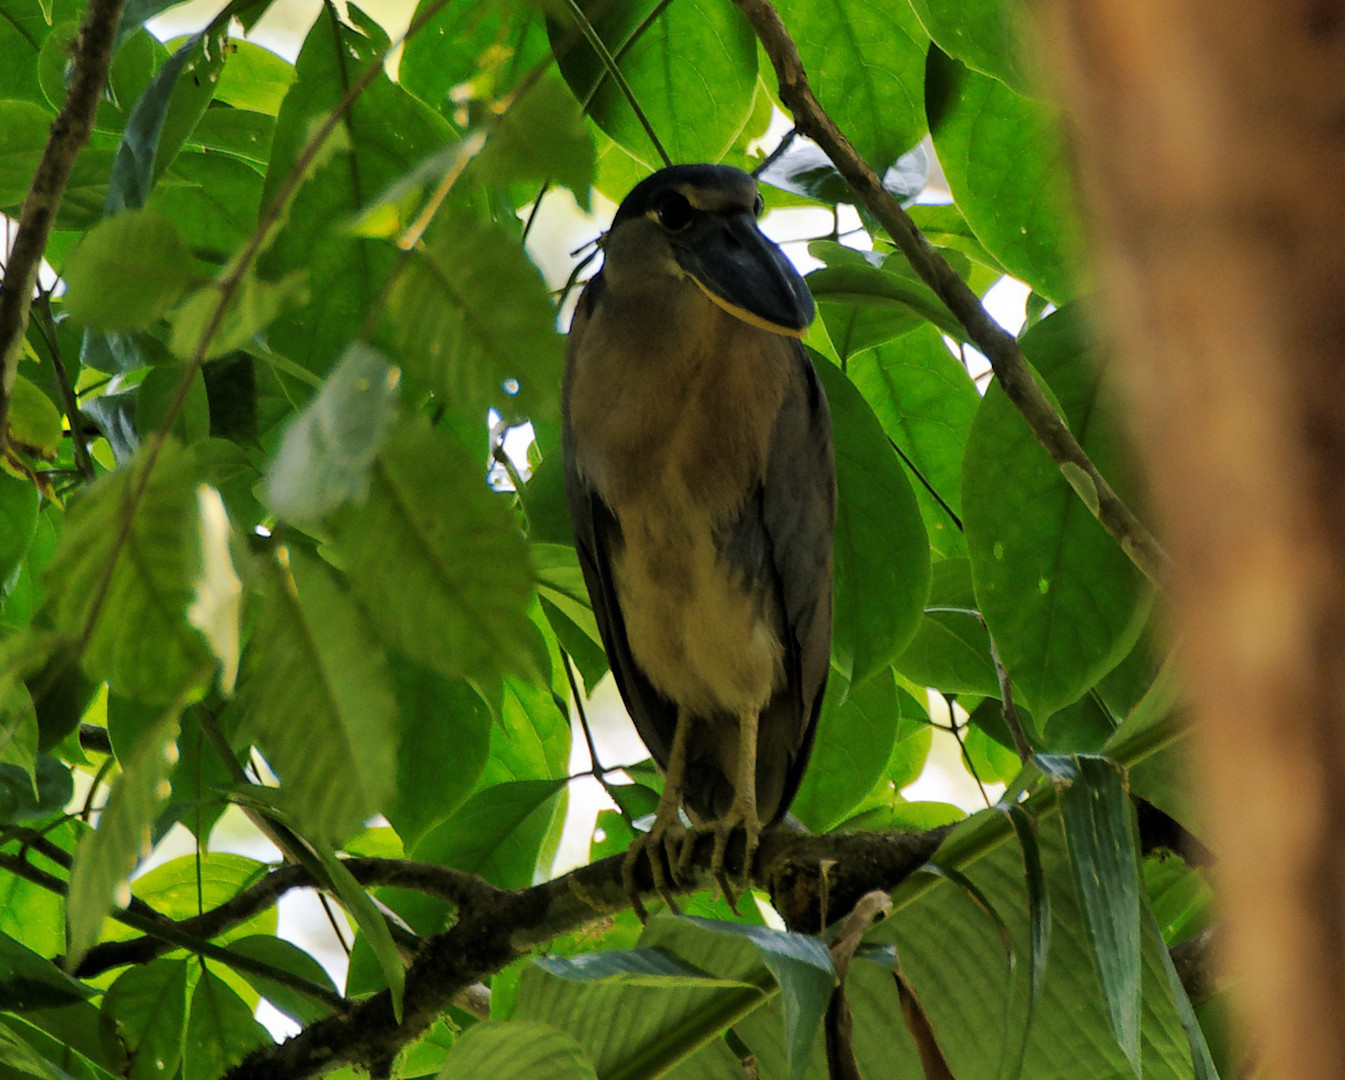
xmin=1041 ymin=0 xmax=1345 ymax=1080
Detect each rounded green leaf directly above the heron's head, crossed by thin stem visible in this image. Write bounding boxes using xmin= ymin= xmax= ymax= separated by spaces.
xmin=547 ymin=0 xmax=757 ymax=165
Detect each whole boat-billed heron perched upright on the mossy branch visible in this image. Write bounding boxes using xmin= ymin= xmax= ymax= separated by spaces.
xmin=562 ymin=165 xmax=835 ymax=916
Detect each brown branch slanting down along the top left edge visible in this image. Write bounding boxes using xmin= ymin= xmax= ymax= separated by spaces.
xmin=0 ymin=0 xmax=125 ymax=455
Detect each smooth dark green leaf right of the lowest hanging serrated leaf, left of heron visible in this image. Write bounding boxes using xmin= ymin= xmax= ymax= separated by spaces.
xmin=383 ymin=655 xmax=492 ymax=849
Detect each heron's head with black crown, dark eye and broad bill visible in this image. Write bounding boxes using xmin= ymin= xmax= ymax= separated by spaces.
xmin=603 ymin=165 xmax=814 ymax=338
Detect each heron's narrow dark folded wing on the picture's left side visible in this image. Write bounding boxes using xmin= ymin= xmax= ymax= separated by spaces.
xmin=561 ymin=274 xmax=677 ymax=767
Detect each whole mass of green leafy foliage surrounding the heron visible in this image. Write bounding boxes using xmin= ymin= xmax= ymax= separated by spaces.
xmin=0 ymin=0 xmax=1227 ymax=1080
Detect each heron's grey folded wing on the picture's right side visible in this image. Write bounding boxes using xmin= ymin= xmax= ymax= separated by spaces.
xmin=757 ymin=338 xmax=837 ymax=820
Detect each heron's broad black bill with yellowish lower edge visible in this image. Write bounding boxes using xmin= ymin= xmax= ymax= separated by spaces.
xmin=674 ymin=214 xmax=814 ymax=338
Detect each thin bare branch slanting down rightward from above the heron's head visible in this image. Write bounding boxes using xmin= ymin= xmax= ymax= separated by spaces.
xmin=733 ymin=0 xmax=1169 ymax=588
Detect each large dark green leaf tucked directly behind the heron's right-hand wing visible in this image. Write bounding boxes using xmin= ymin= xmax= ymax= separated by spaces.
xmin=814 ymin=358 xmax=929 ymax=682
